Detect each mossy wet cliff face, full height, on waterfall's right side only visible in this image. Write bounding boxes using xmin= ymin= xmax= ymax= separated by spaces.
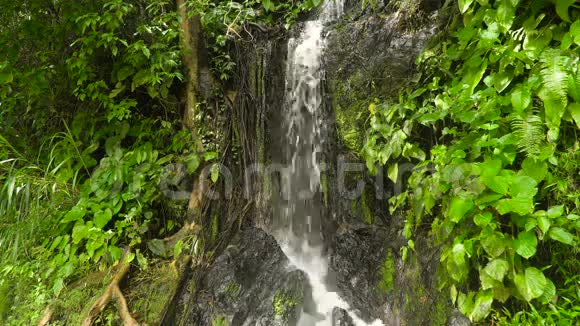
xmin=325 ymin=1 xmax=460 ymax=325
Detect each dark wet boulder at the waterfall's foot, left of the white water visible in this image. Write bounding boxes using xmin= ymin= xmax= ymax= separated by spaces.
xmin=175 ymin=228 xmax=309 ymax=326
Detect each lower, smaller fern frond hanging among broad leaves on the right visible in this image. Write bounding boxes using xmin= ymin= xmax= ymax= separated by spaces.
xmin=512 ymin=112 xmax=546 ymax=157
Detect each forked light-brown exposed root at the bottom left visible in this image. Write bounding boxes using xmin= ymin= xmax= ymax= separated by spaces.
xmin=81 ymin=250 xmax=139 ymax=326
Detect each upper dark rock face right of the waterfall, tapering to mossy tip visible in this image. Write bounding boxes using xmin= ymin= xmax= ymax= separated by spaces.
xmin=324 ymin=0 xmax=436 ymax=157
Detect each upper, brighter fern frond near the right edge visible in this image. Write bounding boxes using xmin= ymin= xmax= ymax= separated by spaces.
xmin=540 ymin=49 xmax=570 ymax=106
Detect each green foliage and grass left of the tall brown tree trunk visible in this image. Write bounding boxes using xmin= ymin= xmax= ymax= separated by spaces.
xmin=0 ymin=0 xmax=227 ymax=324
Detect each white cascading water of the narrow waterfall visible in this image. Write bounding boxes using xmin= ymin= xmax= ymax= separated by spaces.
xmin=274 ymin=0 xmax=383 ymax=326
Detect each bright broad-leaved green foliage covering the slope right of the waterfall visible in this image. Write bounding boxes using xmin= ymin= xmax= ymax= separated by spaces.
xmin=363 ymin=0 xmax=580 ymax=321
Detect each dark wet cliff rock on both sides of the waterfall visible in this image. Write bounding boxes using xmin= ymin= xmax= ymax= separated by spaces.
xmin=167 ymin=1 xmax=472 ymax=325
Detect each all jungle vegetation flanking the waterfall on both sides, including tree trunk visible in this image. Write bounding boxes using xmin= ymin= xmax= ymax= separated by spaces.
xmin=0 ymin=0 xmax=580 ymax=325
